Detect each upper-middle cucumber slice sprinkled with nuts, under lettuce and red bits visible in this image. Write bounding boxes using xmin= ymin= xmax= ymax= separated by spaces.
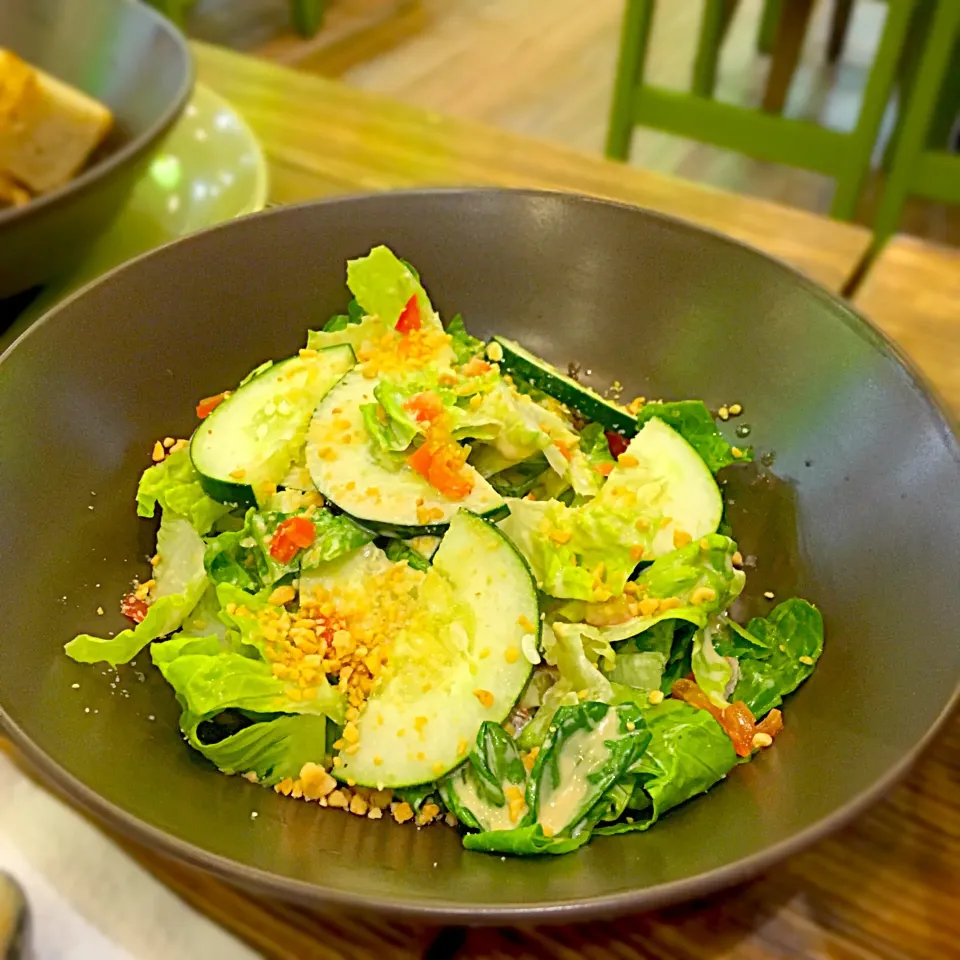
xmin=307 ymin=370 xmax=507 ymax=537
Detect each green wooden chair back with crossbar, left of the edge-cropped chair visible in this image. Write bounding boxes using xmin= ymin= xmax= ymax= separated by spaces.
xmin=606 ymin=0 xmax=920 ymax=220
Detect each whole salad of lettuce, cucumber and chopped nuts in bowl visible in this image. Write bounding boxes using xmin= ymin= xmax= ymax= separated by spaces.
xmin=66 ymin=246 xmax=823 ymax=855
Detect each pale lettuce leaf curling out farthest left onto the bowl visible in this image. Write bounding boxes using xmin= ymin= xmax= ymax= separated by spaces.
xmin=64 ymin=512 xmax=207 ymax=667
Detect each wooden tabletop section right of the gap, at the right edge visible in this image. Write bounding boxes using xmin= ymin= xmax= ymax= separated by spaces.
xmin=854 ymin=236 xmax=960 ymax=416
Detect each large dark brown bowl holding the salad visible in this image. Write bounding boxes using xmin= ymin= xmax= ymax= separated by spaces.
xmin=0 ymin=191 xmax=960 ymax=923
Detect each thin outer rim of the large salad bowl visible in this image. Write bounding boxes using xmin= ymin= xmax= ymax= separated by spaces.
xmin=0 ymin=186 xmax=960 ymax=926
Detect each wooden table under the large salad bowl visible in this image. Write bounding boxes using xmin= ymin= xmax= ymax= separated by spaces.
xmin=3 ymin=45 xmax=960 ymax=960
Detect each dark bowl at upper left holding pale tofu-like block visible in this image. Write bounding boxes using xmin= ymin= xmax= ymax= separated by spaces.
xmin=0 ymin=0 xmax=193 ymax=298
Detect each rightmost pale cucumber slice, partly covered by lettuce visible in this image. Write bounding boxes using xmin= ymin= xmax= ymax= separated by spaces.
xmin=616 ymin=418 xmax=723 ymax=557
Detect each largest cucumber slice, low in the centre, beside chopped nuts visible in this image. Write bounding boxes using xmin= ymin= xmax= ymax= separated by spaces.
xmin=334 ymin=510 xmax=540 ymax=787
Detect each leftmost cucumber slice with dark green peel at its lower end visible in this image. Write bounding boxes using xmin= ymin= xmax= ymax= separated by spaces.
xmin=190 ymin=344 xmax=356 ymax=504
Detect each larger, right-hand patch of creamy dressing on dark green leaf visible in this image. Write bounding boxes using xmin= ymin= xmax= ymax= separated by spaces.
xmin=537 ymin=707 xmax=620 ymax=834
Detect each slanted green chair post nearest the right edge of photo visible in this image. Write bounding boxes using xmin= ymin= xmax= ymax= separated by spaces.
xmin=874 ymin=0 xmax=960 ymax=240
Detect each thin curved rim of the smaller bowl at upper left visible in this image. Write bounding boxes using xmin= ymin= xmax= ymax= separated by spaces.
xmin=0 ymin=0 xmax=196 ymax=228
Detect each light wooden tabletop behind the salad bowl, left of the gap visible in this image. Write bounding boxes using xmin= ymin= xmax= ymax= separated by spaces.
xmin=194 ymin=43 xmax=870 ymax=290
